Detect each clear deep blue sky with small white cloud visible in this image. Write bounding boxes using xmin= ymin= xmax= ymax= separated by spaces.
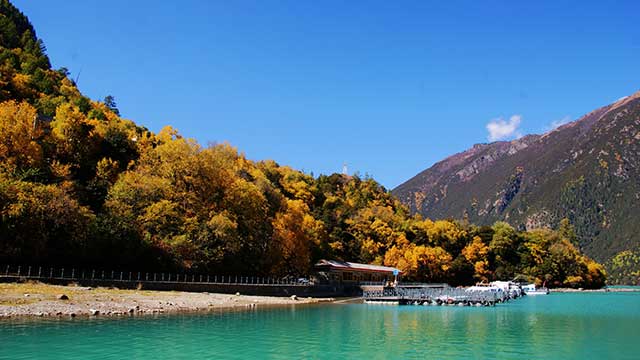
xmin=13 ymin=0 xmax=640 ymax=188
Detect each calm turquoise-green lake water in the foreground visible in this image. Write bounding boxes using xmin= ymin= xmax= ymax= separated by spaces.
xmin=0 ymin=293 xmax=640 ymax=360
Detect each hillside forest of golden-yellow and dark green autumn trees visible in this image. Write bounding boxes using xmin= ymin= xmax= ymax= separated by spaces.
xmin=0 ymin=0 xmax=605 ymax=287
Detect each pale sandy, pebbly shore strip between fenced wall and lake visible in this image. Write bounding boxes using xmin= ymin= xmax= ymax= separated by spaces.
xmin=0 ymin=283 xmax=333 ymax=318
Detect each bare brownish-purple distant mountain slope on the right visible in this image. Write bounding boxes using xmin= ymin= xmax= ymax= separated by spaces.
xmin=392 ymin=92 xmax=640 ymax=268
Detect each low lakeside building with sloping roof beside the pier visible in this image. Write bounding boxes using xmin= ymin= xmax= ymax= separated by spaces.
xmin=314 ymin=260 xmax=402 ymax=283
